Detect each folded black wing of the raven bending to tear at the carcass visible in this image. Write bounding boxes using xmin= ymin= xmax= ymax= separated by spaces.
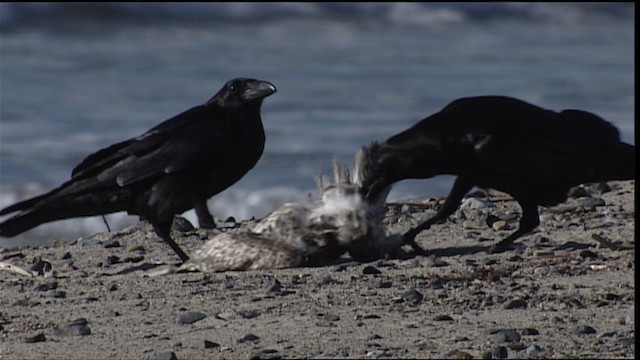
xmin=473 ymin=104 xmax=619 ymax=183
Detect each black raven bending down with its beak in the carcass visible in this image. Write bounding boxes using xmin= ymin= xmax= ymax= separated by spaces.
xmin=362 ymin=96 xmax=635 ymax=252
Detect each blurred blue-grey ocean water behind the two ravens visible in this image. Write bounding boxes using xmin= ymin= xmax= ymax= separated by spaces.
xmin=0 ymin=3 xmax=635 ymax=246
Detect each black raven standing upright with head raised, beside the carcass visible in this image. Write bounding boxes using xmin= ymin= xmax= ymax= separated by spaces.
xmin=0 ymin=78 xmax=276 ymax=261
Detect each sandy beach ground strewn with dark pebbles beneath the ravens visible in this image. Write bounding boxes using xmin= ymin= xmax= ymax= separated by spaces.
xmin=0 ymin=181 xmax=635 ymax=359
